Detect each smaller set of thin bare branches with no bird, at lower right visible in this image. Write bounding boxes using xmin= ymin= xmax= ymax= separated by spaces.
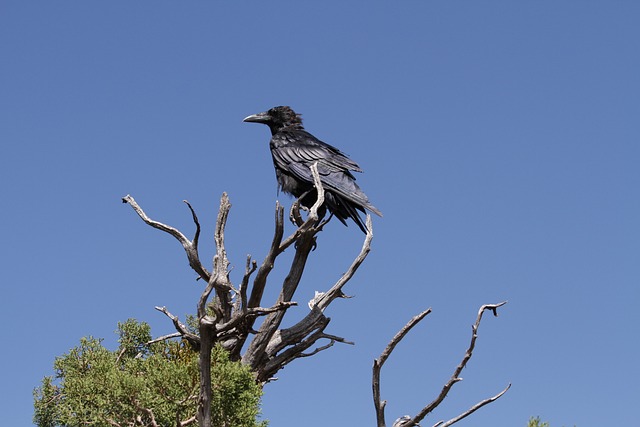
xmin=371 ymin=301 xmax=511 ymax=427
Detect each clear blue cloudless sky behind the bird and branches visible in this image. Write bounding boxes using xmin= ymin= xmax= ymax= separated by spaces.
xmin=0 ymin=0 xmax=640 ymax=427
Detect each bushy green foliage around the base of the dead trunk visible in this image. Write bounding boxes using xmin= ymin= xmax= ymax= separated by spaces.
xmin=34 ymin=319 xmax=266 ymax=427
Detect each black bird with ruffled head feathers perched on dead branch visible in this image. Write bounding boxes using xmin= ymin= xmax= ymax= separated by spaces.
xmin=244 ymin=106 xmax=382 ymax=233
